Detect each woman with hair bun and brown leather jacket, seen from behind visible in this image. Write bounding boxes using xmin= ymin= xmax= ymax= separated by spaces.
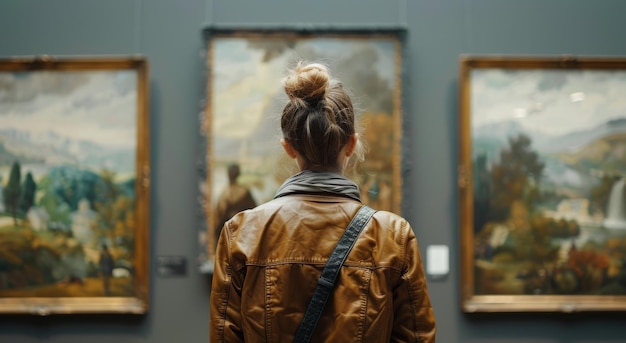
xmin=210 ymin=64 xmax=435 ymax=343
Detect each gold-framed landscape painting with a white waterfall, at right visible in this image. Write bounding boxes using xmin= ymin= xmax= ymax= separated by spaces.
xmin=458 ymin=56 xmax=626 ymax=312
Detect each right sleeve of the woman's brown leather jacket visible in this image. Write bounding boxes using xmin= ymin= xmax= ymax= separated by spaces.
xmin=391 ymin=222 xmax=436 ymax=343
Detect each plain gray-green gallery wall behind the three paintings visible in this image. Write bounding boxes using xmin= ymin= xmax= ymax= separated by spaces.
xmin=0 ymin=0 xmax=626 ymax=343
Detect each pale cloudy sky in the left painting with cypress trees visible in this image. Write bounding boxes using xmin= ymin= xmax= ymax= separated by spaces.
xmin=0 ymin=71 xmax=137 ymax=148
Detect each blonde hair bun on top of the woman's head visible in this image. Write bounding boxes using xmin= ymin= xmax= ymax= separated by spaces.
xmin=283 ymin=62 xmax=330 ymax=106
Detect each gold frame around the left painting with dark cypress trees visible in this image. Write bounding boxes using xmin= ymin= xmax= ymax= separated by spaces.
xmin=0 ymin=56 xmax=150 ymax=316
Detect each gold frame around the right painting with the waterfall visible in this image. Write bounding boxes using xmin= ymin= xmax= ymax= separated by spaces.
xmin=458 ymin=56 xmax=626 ymax=313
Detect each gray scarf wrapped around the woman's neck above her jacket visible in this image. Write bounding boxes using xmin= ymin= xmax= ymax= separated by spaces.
xmin=274 ymin=170 xmax=361 ymax=202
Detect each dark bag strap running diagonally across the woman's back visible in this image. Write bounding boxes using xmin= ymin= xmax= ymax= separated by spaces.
xmin=293 ymin=205 xmax=376 ymax=343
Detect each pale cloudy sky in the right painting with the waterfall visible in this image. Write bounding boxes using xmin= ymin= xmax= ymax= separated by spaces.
xmin=470 ymin=69 xmax=626 ymax=135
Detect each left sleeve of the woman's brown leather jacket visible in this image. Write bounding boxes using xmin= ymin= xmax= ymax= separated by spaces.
xmin=209 ymin=223 xmax=244 ymax=343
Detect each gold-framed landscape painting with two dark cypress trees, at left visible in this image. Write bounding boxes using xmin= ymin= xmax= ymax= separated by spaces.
xmin=0 ymin=56 xmax=150 ymax=315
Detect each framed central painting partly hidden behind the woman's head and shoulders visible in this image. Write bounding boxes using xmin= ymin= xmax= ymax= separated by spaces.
xmin=199 ymin=30 xmax=402 ymax=273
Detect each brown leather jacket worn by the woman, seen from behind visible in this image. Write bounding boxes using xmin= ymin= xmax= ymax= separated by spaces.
xmin=210 ymin=195 xmax=435 ymax=343
